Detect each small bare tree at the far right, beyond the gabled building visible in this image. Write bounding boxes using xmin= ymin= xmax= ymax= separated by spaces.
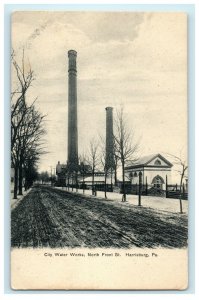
xmin=167 ymin=153 xmax=188 ymax=214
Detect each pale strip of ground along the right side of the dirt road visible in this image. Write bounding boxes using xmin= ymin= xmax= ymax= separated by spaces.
xmin=56 ymin=187 xmax=188 ymax=214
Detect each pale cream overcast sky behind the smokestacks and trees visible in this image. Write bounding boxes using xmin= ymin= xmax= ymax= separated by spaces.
xmin=12 ymin=12 xmax=187 ymax=176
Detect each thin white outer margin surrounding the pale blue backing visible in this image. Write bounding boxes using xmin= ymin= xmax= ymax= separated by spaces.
xmin=0 ymin=0 xmax=199 ymax=300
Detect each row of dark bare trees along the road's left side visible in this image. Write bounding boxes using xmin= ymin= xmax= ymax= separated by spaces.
xmin=11 ymin=51 xmax=45 ymax=199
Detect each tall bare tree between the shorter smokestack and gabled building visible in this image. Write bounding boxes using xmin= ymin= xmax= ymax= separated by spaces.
xmin=114 ymin=107 xmax=139 ymax=202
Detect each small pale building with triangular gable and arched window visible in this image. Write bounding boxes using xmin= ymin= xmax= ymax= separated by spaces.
xmin=125 ymin=154 xmax=173 ymax=189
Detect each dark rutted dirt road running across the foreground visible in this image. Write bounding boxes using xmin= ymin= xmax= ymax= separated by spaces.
xmin=11 ymin=186 xmax=188 ymax=248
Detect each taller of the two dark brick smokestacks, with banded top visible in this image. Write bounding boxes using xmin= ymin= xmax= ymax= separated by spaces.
xmin=68 ymin=50 xmax=78 ymax=168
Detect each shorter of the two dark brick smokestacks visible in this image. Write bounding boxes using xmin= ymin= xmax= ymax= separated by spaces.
xmin=105 ymin=107 xmax=114 ymax=170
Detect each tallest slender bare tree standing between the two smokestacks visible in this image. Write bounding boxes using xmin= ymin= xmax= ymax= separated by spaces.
xmin=88 ymin=138 xmax=99 ymax=195
